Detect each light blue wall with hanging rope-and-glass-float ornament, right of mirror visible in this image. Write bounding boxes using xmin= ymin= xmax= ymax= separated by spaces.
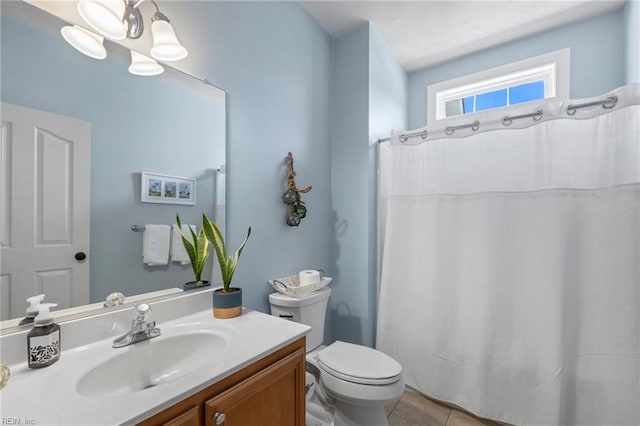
xmin=181 ymin=1 xmax=335 ymax=312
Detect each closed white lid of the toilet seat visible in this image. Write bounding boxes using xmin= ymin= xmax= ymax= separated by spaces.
xmin=318 ymin=341 xmax=402 ymax=385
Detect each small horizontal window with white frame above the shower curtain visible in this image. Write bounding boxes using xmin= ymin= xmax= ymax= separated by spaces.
xmin=427 ymin=49 xmax=569 ymax=123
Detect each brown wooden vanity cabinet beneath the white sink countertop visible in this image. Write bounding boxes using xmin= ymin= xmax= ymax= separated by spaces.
xmin=140 ymin=337 xmax=305 ymax=426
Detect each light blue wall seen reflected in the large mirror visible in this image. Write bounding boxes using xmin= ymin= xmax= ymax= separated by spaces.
xmin=1 ymin=16 xmax=225 ymax=301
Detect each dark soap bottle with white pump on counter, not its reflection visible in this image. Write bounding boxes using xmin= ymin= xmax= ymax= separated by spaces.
xmin=27 ymin=303 xmax=60 ymax=368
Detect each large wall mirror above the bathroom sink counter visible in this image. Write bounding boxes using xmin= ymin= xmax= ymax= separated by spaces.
xmin=0 ymin=1 xmax=226 ymax=326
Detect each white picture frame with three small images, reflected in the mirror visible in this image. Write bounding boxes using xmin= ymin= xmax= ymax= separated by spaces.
xmin=140 ymin=172 xmax=196 ymax=206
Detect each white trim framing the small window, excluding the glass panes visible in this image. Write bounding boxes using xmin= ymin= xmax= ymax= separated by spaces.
xmin=427 ymin=48 xmax=571 ymax=125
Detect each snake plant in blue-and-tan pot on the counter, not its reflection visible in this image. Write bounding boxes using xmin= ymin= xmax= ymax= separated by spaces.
xmin=202 ymin=214 xmax=251 ymax=318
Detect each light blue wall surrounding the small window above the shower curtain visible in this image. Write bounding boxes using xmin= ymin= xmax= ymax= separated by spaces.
xmin=408 ymin=9 xmax=626 ymax=129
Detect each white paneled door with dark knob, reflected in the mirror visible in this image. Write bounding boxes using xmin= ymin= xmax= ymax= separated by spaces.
xmin=0 ymin=103 xmax=91 ymax=320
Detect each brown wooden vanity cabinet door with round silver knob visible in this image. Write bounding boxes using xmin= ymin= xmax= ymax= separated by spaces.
xmin=205 ymin=349 xmax=305 ymax=426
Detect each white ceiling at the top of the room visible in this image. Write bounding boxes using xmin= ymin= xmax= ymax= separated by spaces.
xmin=299 ymin=0 xmax=624 ymax=72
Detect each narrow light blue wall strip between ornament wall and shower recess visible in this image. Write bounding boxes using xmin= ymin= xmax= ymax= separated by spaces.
xmin=327 ymin=23 xmax=374 ymax=346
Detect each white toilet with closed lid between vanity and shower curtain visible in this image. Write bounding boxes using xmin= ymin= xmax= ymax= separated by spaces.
xmin=269 ymin=287 xmax=404 ymax=426
